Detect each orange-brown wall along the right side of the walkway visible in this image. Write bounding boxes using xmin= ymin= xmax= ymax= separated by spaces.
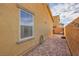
xmin=65 ymin=17 xmax=79 ymax=55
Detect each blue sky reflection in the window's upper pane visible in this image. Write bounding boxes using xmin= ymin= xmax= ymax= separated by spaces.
xmin=20 ymin=10 xmax=33 ymax=26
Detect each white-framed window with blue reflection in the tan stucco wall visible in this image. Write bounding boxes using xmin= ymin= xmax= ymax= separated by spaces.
xmin=20 ymin=9 xmax=34 ymax=40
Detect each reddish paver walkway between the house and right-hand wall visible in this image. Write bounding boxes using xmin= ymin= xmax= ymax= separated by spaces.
xmin=25 ymin=35 xmax=70 ymax=56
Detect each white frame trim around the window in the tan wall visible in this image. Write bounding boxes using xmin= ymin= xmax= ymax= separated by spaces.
xmin=18 ymin=9 xmax=34 ymax=43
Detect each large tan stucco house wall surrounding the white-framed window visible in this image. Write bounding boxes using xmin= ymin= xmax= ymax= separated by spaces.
xmin=0 ymin=4 xmax=52 ymax=55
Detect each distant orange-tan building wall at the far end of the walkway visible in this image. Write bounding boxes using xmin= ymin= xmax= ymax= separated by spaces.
xmin=53 ymin=16 xmax=63 ymax=34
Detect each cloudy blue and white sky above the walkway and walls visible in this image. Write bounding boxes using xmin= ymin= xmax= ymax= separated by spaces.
xmin=49 ymin=3 xmax=79 ymax=26
